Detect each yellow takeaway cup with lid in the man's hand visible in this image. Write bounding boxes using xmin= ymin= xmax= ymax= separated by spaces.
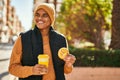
xmin=38 ymin=54 xmax=49 ymax=67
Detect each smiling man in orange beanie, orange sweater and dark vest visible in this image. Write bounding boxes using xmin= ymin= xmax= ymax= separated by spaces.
xmin=9 ymin=3 xmax=76 ymax=80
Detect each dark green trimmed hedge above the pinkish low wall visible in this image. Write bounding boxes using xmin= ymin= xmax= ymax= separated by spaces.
xmin=69 ymin=47 xmax=120 ymax=67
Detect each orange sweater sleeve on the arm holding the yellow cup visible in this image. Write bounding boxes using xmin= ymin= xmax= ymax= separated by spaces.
xmin=9 ymin=36 xmax=33 ymax=78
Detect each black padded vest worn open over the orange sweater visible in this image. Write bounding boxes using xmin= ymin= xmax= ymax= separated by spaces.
xmin=19 ymin=27 xmax=66 ymax=80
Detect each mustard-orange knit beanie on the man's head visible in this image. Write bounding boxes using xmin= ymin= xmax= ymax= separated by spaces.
xmin=34 ymin=3 xmax=55 ymax=26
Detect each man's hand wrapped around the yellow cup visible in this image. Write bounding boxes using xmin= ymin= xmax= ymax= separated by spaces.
xmin=33 ymin=64 xmax=48 ymax=75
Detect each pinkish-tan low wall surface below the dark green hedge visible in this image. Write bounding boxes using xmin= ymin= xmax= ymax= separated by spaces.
xmin=66 ymin=67 xmax=120 ymax=80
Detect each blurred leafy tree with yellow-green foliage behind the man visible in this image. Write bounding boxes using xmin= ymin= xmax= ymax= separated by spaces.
xmin=56 ymin=0 xmax=112 ymax=48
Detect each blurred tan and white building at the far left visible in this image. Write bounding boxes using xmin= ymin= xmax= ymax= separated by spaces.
xmin=0 ymin=0 xmax=23 ymax=43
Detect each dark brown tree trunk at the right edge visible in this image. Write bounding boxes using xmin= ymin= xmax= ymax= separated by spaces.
xmin=110 ymin=0 xmax=120 ymax=49
